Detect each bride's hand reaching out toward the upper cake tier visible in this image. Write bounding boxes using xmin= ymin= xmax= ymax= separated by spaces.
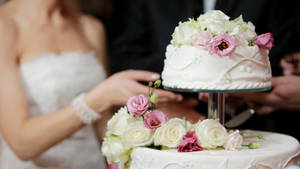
xmin=86 ymin=70 xmax=182 ymax=109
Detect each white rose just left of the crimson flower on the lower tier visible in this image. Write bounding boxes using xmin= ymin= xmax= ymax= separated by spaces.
xmin=154 ymin=118 xmax=187 ymax=148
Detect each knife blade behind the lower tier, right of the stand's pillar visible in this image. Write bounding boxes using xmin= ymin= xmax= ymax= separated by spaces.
xmin=225 ymin=108 xmax=255 ymax=128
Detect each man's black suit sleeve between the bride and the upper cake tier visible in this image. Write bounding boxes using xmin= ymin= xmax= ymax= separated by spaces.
xmin=109 ymin=0 xmax=155 ymax=73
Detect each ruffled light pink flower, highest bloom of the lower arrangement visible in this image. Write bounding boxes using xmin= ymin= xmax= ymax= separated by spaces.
xmin=127 ymin=95 xmax=150 ymax=116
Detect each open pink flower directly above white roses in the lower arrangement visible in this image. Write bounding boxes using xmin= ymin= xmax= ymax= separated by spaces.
xmin=144 ymin=110 xmax=168 ymax=130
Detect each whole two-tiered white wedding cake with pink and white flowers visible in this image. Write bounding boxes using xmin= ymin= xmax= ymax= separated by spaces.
xmin=102 ymin=11 xmax=300 ymax=169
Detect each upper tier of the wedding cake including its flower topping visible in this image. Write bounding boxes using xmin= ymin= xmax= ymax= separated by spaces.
xmin=162 ymin=11 xmax=273 ymax=90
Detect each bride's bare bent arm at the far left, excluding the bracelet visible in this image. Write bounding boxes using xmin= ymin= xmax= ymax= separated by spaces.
xmin=0 ymin=19 xmax=110 ymax=160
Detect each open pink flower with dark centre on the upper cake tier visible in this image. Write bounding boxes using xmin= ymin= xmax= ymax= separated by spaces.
xmin=209 ymin=33 xmax=236 ymax=57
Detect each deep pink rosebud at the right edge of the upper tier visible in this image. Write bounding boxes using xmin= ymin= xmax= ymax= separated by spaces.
xmin=254 ymin=32 xmax=274 ymax=50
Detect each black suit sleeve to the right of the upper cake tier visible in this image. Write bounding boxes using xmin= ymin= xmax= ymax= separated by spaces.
xmin=261 ymin=0 xmax=300 ymax=76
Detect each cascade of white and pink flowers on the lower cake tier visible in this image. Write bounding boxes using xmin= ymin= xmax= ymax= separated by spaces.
xmin=102 ymin=80 xmax=259 ymax=169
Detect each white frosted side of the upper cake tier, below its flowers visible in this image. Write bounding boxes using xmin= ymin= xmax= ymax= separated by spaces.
xmin=162 ymin=45 xmax=272 ymax=90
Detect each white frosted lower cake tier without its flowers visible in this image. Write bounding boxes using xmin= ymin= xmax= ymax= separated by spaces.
xmin=130 ymin=131 xmax=300 ymax=169
